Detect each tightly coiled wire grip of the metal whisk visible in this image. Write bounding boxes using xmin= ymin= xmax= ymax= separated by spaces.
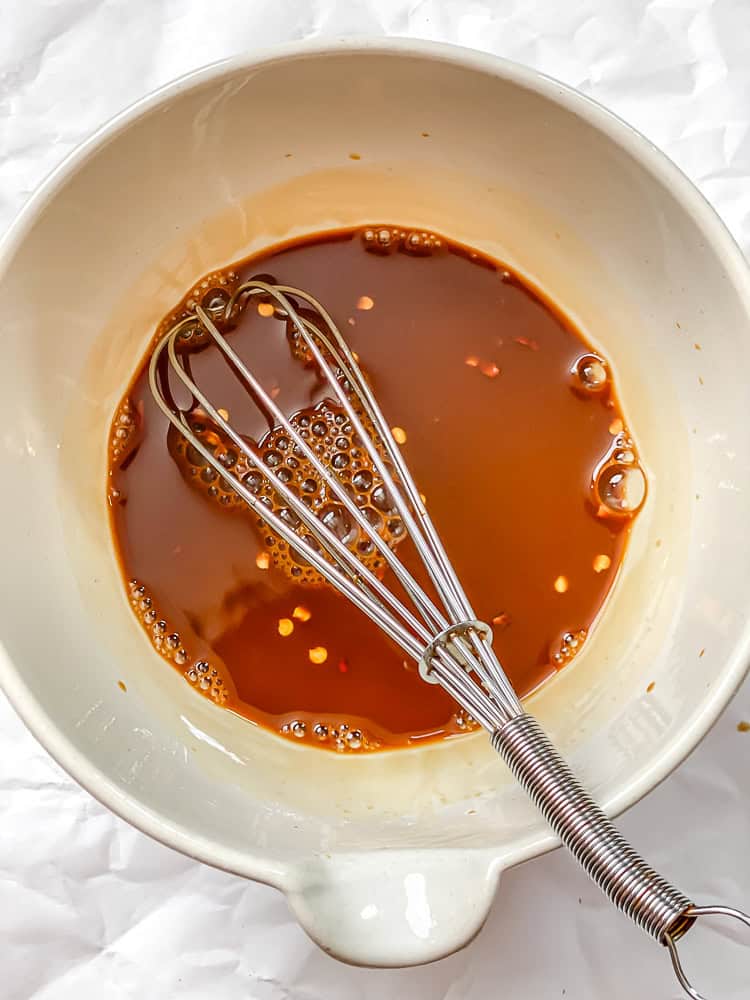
xmin=492 ymin=714 xmax=694 ymax=944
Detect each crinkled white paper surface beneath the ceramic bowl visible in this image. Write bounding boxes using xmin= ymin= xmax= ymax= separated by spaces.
xmin=0 ymin=0 xmax=750 ymax=1000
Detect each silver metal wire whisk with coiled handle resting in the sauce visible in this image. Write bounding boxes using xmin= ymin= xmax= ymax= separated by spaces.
xmin=149 ymin=279 xmax=750 ymax=1000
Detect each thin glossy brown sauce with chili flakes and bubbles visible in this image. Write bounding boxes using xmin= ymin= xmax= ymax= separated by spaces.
xmin=109 ymin=227 xmax=645 ymax=751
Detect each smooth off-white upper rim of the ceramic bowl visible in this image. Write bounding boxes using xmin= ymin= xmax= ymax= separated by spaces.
xmin=0 ymin=36 xmax=750 ymax=892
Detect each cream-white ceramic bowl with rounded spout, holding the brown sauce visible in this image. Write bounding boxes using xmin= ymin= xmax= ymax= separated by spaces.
xmin=0 ymin=41 xmax=750 ymax=965
